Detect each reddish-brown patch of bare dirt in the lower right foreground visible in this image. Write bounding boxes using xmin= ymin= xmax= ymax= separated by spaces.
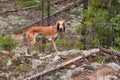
xmin=75 ymin=66 xmax=118 ymax=80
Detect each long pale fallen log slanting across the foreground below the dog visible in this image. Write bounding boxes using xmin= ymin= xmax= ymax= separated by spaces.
xmin=24 ymin=49 xmax=100 ymax=80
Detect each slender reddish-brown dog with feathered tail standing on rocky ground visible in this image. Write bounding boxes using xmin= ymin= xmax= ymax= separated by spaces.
xmin=12 ymin=20 xmax=66 ymax=55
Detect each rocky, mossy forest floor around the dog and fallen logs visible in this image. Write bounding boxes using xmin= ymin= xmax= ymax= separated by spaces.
xmin=0 ymin=0 xmax=120 ymax=80
